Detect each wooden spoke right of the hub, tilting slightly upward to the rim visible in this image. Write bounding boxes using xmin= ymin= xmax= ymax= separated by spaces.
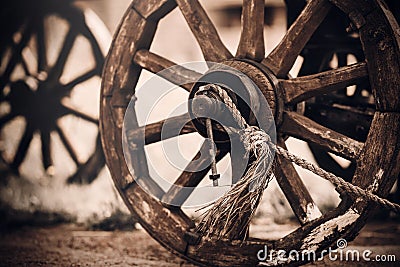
xmin=279 ymin=62 xmax=368 ymax=103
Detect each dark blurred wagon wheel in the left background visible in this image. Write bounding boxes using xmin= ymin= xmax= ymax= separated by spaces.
xmin=0 ymin=1 xmax=108 ymax=183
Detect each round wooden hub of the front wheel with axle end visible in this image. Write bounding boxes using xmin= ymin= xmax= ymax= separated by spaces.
xmin=189 ymin=59 xmax=283 ymax=142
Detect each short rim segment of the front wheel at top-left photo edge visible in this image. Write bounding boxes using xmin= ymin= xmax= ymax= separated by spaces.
xmin=132 ymin=0 xmax=176 ymax=21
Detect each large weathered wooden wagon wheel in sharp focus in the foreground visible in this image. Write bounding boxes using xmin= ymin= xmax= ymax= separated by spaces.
xmin=100 ymin=0 xmax=400 ymax=266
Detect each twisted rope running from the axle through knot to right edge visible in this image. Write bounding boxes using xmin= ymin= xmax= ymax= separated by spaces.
xmin=210 ymin=85 xmax=400 ymax=213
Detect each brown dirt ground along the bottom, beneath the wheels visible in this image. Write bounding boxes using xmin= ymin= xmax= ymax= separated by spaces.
xmin=0 ymin=222 xmax=400 ymax=267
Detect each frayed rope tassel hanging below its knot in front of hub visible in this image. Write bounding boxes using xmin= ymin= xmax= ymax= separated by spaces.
xmin=196 ymin=126 xmax=274 ymax=240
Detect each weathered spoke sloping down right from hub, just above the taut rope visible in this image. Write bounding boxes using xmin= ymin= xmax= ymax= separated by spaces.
xmin=280 ymin=112 xmax=363 ymax=159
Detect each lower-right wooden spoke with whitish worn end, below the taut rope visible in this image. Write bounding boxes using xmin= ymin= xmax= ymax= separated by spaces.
xmin=274 ymin=139 xmax=322 ymax=225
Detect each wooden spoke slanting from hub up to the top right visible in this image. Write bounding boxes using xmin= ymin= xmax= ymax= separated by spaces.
xmin=263 ymin=0 xmax=331 ymax=78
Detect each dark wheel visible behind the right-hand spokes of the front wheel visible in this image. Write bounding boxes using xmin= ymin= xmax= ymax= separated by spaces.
xmin=286 ymin=0 xmax=400 ymax=201
